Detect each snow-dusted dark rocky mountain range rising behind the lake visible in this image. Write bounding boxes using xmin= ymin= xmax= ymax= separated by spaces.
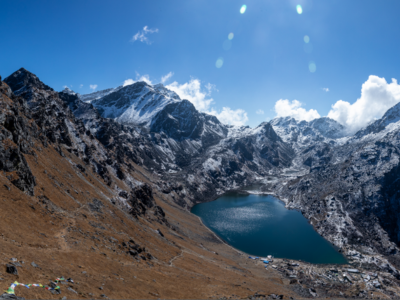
xmin=0 ymin=68 xmax=400 ymax=298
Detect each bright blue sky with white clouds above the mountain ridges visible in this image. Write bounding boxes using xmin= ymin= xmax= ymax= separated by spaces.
xmin=0 ymin=0 xmax=400 ymax=128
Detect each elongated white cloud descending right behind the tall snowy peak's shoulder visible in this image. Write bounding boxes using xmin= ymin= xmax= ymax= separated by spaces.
xmin=166 ymin=78 xmax=248 ymax=125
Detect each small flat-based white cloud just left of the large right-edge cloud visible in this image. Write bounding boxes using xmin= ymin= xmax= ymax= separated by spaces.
xmin=275 ymin=99 xmax=321 ymax=121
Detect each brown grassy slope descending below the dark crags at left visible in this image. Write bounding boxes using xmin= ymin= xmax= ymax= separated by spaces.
xmin=0 ymin=87 xmax=292 ymax=299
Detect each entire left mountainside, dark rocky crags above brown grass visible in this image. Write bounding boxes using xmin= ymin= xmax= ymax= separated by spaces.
xmin=0 ymin=70 xmax=294 ymax=299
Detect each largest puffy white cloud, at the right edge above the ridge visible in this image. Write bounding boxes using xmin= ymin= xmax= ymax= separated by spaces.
xmin=328 ymin=75 xmax=400 ymax=133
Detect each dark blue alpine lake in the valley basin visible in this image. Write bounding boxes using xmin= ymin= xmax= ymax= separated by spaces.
xmin=191 ymin=185 xmax=347 ymax=264
